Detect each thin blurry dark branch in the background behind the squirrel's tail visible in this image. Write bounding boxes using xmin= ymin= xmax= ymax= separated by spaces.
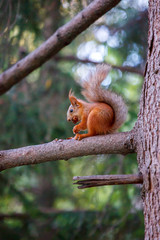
xmin=54 ymin=55 xmax=144 ymax=76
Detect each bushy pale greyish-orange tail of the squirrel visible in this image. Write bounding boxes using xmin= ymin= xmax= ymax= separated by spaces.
xmin=82 ymin=64 xmax=127 ymax=132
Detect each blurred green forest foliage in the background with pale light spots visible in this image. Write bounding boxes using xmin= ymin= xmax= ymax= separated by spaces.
xmin=0 ymin=0 xmax=147 ymax=240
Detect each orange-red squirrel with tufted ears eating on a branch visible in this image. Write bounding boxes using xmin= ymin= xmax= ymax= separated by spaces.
xmin=67 ymin=64 xmax=127 ymax=140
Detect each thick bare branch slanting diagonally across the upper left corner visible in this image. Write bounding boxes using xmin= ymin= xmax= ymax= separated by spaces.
xmin=0 ymin=0 xmax=120 ymax=95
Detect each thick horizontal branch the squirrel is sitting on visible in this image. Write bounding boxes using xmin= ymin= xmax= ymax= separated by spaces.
xmin=0 ymin=132 xmax=135 ymax=171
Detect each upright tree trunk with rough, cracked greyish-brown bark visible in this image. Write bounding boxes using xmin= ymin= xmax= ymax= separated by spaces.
xmin=136 ymin=0 xmax=160 ymax=240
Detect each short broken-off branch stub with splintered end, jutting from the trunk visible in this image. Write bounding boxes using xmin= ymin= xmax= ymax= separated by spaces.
xmin=73 ymin=174 xmax=143 ymax=189
